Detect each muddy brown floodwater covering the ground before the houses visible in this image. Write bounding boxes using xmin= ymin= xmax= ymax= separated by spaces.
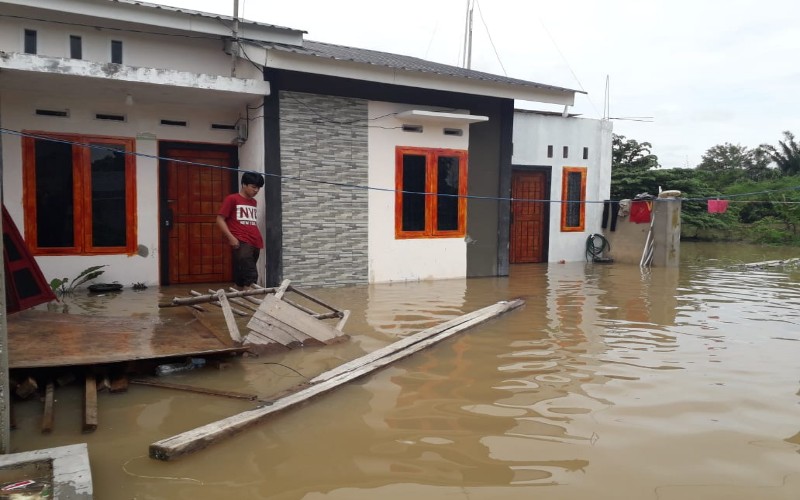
xmin=12 ymin=243 xmax=800 ymax=500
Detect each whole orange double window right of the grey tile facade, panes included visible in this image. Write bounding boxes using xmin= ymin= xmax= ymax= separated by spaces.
xmin=395 ymin=147 xmax=467 ymax=239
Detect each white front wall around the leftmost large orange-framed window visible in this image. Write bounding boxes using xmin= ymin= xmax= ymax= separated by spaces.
xmin=0 ymin=91 xmax=263 ymax=286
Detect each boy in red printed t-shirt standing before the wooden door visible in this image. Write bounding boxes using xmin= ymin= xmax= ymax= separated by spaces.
xmin=217 ymin=172 xmax=264 ymax=288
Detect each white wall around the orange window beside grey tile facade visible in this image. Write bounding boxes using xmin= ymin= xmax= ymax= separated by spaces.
xmin=368 ymin=102 xmax=476 ymax=283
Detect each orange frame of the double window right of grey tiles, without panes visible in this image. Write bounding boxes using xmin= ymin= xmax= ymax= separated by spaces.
xmin=394 ymin=146 xmax=468 ymax=239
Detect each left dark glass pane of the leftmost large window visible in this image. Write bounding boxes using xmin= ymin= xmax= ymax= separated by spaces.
xmin=35 ymin=140 xmax=75 ymax=248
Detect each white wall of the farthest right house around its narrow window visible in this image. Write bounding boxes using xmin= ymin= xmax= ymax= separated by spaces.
xmin=511 ymin=110 xmax=612 ymax=262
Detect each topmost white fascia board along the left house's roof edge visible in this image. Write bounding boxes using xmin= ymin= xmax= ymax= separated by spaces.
xmin=0 ymin=0 xmax=303 ymax=45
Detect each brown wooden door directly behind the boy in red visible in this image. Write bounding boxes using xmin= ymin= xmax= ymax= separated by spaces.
xmin=162 ymin=149 xmax=234 ymax=284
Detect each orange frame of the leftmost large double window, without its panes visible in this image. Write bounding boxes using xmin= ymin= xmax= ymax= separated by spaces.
xmin=22 ymin=131 xmax=137 ymax=255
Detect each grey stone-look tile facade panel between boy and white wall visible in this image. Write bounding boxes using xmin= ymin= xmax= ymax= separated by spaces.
xmin=280 ymin=92 xmax=368 ymax=286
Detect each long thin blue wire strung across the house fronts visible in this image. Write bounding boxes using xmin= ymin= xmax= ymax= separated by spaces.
xmin=0 ymin=129 xmax=800 ymax=209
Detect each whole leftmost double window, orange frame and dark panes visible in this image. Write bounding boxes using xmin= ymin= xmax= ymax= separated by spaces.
xmin=22 ymin=132 xmax=137 ymax=255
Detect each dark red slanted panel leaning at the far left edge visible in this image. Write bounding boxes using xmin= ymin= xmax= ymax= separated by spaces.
xmin=3 ymin=206 xmax=56 ymax=313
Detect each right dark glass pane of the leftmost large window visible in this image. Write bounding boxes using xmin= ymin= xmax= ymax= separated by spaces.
xmin=92 ymin=144 xmax=127 ymax=247
